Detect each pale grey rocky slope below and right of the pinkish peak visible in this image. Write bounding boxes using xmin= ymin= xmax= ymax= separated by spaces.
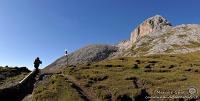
xmin=121 ymin=24 xmax=200 ymax=56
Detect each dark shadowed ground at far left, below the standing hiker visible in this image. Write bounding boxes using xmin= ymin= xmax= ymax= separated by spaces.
xmin=0 ymin=67 xmax=36 ymax=101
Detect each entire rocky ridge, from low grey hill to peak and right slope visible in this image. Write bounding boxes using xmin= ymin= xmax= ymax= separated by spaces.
xmin=47 ymin=15 xmax=200 ymax=69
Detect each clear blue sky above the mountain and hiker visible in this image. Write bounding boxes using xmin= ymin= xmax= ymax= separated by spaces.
xmin=0 ymin=0 xmax=200 ymax=69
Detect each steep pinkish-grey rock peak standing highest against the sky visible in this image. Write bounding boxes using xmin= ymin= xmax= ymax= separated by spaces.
xmin=130 ymin=15 xmax=171 ymax=43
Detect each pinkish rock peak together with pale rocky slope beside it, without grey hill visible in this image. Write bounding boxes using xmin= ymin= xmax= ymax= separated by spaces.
xmin=114 ymin=15 xmax=200 ymax=57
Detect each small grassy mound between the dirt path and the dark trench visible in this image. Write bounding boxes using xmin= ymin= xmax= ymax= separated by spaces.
xmin=33 ymin=74 xmax=83 ymax=101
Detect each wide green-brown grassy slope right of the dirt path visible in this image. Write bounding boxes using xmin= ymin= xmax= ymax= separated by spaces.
xmin=63 ymin=52 xmax=200 ymax=100
